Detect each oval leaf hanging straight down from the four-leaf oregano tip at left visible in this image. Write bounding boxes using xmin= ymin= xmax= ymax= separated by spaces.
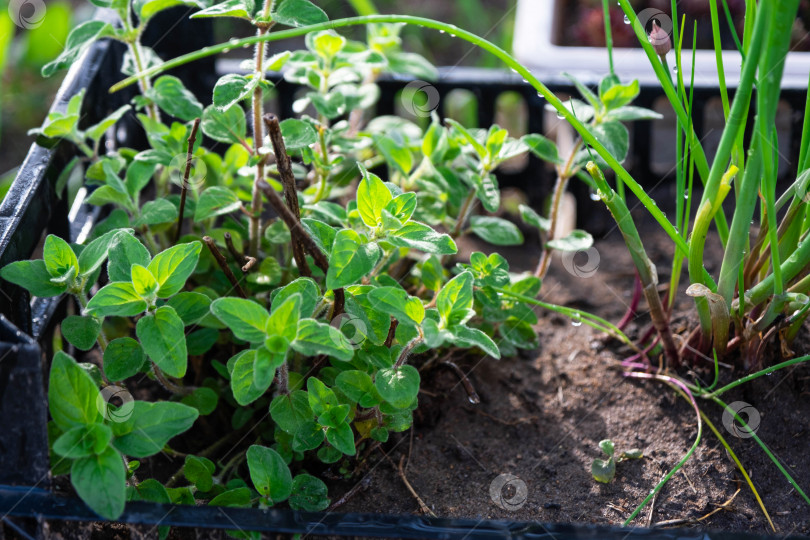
xmin=135 ymin=306 xmax=188 ymax=378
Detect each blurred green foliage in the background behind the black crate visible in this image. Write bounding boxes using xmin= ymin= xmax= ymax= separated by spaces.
xmin=0 ymin=0 xmax=516 ymax=194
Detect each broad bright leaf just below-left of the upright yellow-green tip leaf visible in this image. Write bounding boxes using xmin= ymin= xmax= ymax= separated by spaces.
xmin=326 ymin=228 xmax=378 ymax=289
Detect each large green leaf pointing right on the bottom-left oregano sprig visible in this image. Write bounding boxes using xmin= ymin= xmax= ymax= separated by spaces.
xmin=113 ymin=401 xmax=199 ymax=458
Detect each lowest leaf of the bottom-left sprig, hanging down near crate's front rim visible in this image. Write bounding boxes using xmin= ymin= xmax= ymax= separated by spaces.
xmin=70 ymin=447 xmax=126 ymax=520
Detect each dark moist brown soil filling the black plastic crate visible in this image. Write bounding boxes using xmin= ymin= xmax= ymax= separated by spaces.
xmin=6 ymin=216 xmax=810 ymax=539
